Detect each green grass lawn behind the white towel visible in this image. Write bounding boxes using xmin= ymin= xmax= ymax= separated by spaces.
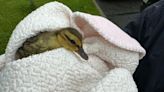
xmin=0 ymin=0 xmax=100 ymax=54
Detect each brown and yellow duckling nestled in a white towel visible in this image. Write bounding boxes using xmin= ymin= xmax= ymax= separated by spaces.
xmin=15 ymin=28 xmax=88 ymax=60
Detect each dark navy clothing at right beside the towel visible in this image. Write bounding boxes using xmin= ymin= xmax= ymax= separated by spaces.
xmin=125 ymin=0 xmax=164 ymax=92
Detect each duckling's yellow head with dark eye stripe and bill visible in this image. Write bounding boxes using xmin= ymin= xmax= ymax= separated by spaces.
xmin=57 ymin=28 xmax=88 ymax=60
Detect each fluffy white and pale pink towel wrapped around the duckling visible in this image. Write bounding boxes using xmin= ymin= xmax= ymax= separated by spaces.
xmin=0 ymin=2 xmax=145 ymax=92
